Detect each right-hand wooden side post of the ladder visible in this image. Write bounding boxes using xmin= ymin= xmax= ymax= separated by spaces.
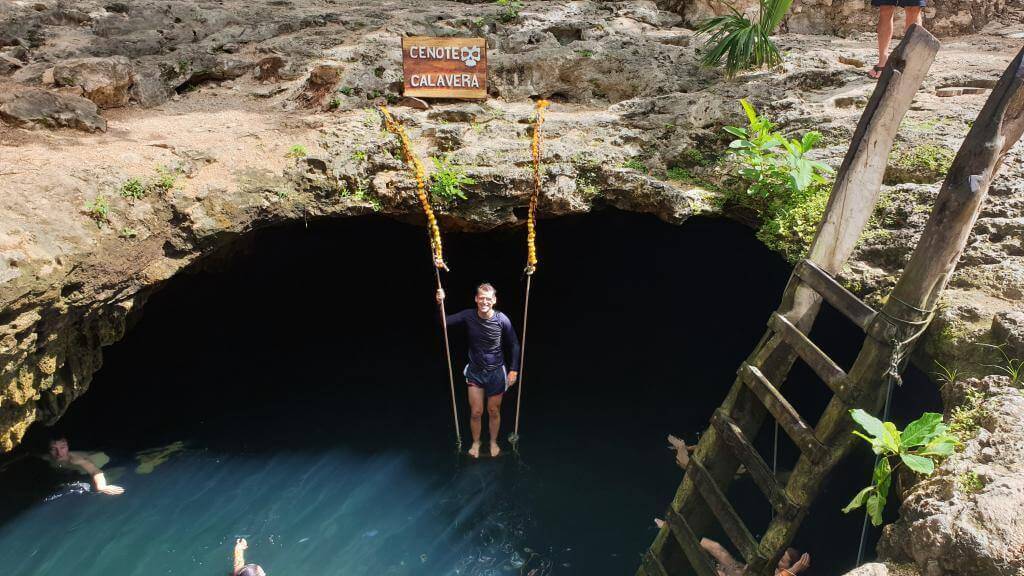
xmin=761 ymin=44 xmax=1024 ymax=565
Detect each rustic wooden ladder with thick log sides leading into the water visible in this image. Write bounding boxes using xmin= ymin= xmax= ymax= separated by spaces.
xmin=637 ymin=32 xmax=1024 ymax=576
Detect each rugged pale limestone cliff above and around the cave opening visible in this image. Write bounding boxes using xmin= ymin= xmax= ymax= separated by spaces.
xmin=0 ymin=0 xmax=1024 ymax=569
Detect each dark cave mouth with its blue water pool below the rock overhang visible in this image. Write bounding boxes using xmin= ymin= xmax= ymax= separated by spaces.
xmin=0 ymin=210 xmax=938 ymax=576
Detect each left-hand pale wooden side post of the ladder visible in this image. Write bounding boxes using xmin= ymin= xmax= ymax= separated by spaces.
xmin=637 ymin=26 xmax=939 ymax=576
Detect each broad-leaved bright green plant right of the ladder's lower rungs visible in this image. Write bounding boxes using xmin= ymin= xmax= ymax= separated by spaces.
xmin=843 ymin=408 xmax=956 ymax=526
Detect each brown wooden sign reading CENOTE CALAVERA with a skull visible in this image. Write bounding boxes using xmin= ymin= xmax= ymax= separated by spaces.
xmin=401 ymin=36 xmax=487 ymax=98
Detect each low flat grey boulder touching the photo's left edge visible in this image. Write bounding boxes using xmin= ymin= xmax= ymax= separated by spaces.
xmin=0 ymin=88 xmax=106 ymax=132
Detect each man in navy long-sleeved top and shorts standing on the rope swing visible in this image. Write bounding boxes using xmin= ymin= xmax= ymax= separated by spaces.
xmin=437 ymin=284 xmax=519 ymax=458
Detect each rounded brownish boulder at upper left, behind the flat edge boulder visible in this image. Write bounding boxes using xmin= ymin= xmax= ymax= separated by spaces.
xmin=53 ymin=56 xmax=132 ymax=108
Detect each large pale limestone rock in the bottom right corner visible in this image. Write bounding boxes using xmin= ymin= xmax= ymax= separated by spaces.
xmin=879 ymin=376 xmax=1024 ymax=576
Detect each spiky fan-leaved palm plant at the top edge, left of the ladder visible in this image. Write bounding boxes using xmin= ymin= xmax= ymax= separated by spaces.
xmin=697 ymin=0 xmax=793 ymax=78
